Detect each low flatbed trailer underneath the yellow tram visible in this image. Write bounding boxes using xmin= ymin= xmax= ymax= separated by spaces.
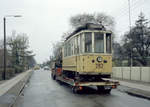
xmin=51 ymin=68 xmax=119 ymax=93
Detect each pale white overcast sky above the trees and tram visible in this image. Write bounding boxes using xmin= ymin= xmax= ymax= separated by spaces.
xmin=0 ymin=0 xmax=150 ymax=63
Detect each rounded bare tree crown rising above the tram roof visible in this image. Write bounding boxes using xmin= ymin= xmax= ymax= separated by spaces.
xmin=70 ymin=13 xmax=115 ymax=31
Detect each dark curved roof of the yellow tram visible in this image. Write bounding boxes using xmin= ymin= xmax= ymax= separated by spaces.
xmin=66 ymin=23 xmax=106 ymax=40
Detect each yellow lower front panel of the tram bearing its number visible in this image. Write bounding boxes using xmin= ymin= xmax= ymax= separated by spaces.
xmin=79 ymin=55 xmax=112 ymax=75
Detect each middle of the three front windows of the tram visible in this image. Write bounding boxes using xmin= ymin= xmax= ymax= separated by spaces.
xmin=94 ymin=32 xmax=104 ymax=53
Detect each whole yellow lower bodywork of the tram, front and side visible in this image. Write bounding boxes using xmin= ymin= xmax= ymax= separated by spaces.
xmin=63 ymin=55 xmax=112 ymax=77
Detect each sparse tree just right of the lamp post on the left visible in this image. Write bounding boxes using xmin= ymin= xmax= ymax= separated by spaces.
xmin=7 ymin=32 xmax=34 ymax=72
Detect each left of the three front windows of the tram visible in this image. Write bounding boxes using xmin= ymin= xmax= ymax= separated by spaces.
xmin=85 ymin=32 xmax=92 ymax=53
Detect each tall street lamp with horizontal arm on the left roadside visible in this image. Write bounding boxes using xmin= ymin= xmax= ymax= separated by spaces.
xmin=3 ymin=15 xmax=21 ymax=80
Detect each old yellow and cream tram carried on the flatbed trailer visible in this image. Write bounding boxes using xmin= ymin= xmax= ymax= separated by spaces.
xmin=62 ymin=23 xmax=112 ymax=78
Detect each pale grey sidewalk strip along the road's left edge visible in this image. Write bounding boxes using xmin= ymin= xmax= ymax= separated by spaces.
xmin=0 ymin=71 xmax=32 ymax=107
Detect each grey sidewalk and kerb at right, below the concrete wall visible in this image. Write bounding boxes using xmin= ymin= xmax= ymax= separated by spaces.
xmin=113 ymin=79 xmax=150 ymax=100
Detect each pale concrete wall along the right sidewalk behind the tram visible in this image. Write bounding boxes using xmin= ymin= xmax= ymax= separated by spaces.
xmin=112 ymin=67 xmax=150 ymax=82
